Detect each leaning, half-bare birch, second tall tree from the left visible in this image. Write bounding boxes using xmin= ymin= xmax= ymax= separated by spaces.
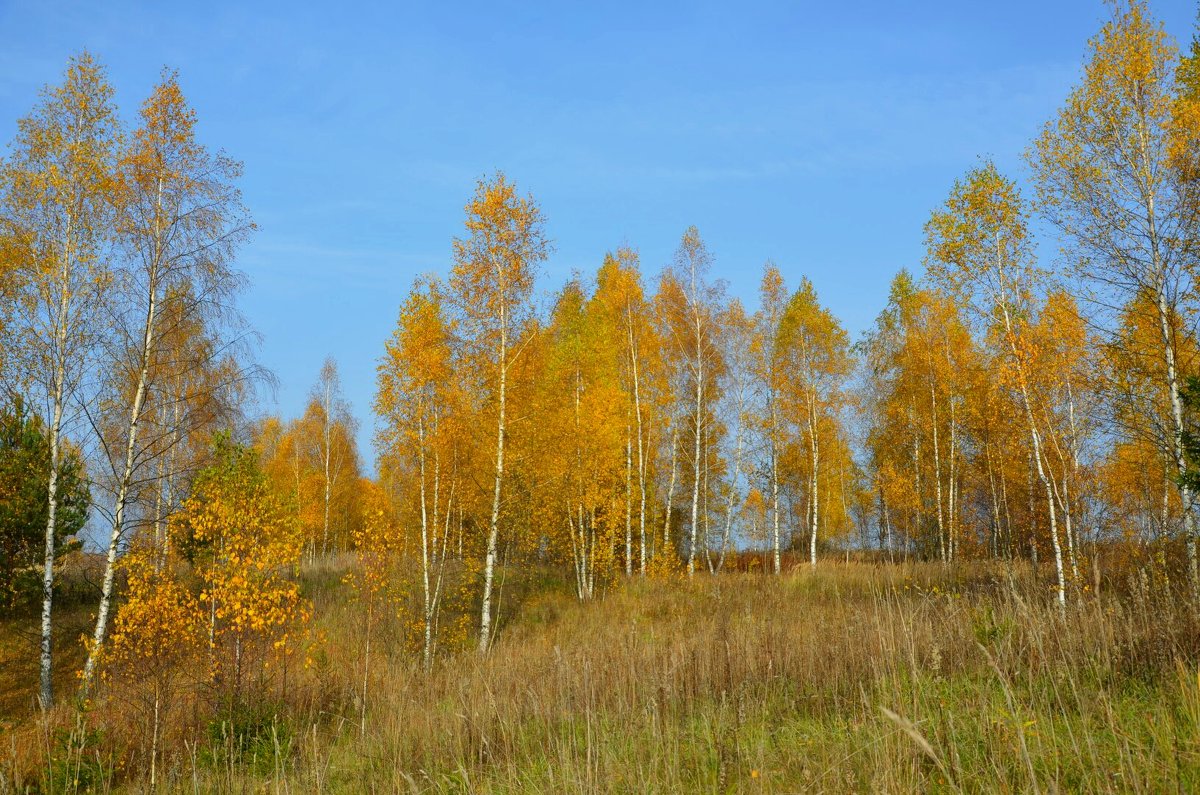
xmin=82 ymin=73 xmax=253 ymax=692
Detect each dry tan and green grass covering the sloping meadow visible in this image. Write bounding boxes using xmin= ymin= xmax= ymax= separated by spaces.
xmin=0 ymin=562 xmax=1200 ymax=793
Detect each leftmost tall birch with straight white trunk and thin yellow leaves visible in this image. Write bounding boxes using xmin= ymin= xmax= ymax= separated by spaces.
xmin=0 ymin=53 xmax=120 ymax=709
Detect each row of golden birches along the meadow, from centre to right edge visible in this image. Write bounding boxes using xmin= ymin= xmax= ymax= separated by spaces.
xmin=371 ymin=2 xmax=1200 ymax=656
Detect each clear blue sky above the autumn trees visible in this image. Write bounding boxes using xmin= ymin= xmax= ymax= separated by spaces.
xmin=0 ymin=0 xmax=1196 ymax=462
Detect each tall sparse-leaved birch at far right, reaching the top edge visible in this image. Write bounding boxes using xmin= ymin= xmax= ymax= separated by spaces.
xmin=1028 ymin=0 xmax=1200 ymax=598
